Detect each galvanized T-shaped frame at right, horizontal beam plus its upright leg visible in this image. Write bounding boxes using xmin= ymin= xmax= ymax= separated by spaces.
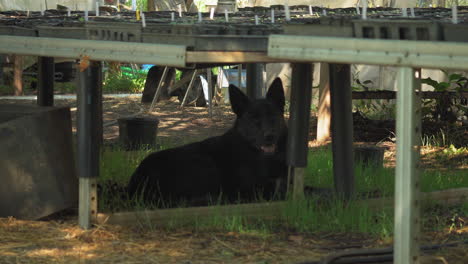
xmin=268 ymin=35 xmax=468 ymax=263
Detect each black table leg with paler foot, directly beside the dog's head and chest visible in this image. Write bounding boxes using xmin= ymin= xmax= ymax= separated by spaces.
xmin=286 ymin=63 xmax=314 ymax=198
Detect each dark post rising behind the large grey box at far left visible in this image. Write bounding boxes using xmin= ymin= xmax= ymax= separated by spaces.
xmin=37 ymin=57 xmax=55 ymax=106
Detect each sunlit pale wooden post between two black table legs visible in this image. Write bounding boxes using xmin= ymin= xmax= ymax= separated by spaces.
xmin=317 ymin=62 xmax=331 ymax=143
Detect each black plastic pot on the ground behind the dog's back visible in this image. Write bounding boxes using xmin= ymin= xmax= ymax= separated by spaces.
xmin=118 ymin=117 xmax=159 ymax=150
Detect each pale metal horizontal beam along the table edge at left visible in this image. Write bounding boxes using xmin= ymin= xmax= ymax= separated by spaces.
xmin=0 ymin=36 xmax=186 ymax=67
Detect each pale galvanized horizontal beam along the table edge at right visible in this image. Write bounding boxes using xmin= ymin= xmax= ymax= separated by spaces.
xmin=268 ymin=35 xmax=468 ymax=70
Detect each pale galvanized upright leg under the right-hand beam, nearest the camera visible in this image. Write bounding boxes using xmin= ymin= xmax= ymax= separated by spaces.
xmin=394 ymin=67 xmax=421 ymax=263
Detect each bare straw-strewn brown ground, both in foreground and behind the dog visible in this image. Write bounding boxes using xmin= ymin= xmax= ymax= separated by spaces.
xmin=0 ymin=97 xmax=468 ymax=264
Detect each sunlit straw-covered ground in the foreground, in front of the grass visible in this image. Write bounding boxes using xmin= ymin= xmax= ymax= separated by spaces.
xmin=0 ymin=218 xmax=468 ymax=264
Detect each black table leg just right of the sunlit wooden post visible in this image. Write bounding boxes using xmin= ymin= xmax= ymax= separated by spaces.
xmin=330 ymin=64 xmax=354 ymax=199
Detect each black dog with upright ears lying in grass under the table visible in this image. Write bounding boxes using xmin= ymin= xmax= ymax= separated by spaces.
xmin=128 ymin=78 xmax=287 ymax=205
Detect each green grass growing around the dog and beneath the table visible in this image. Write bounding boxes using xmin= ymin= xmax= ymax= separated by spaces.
xmin=99 ymin=145 xmax=468 ymax=239
